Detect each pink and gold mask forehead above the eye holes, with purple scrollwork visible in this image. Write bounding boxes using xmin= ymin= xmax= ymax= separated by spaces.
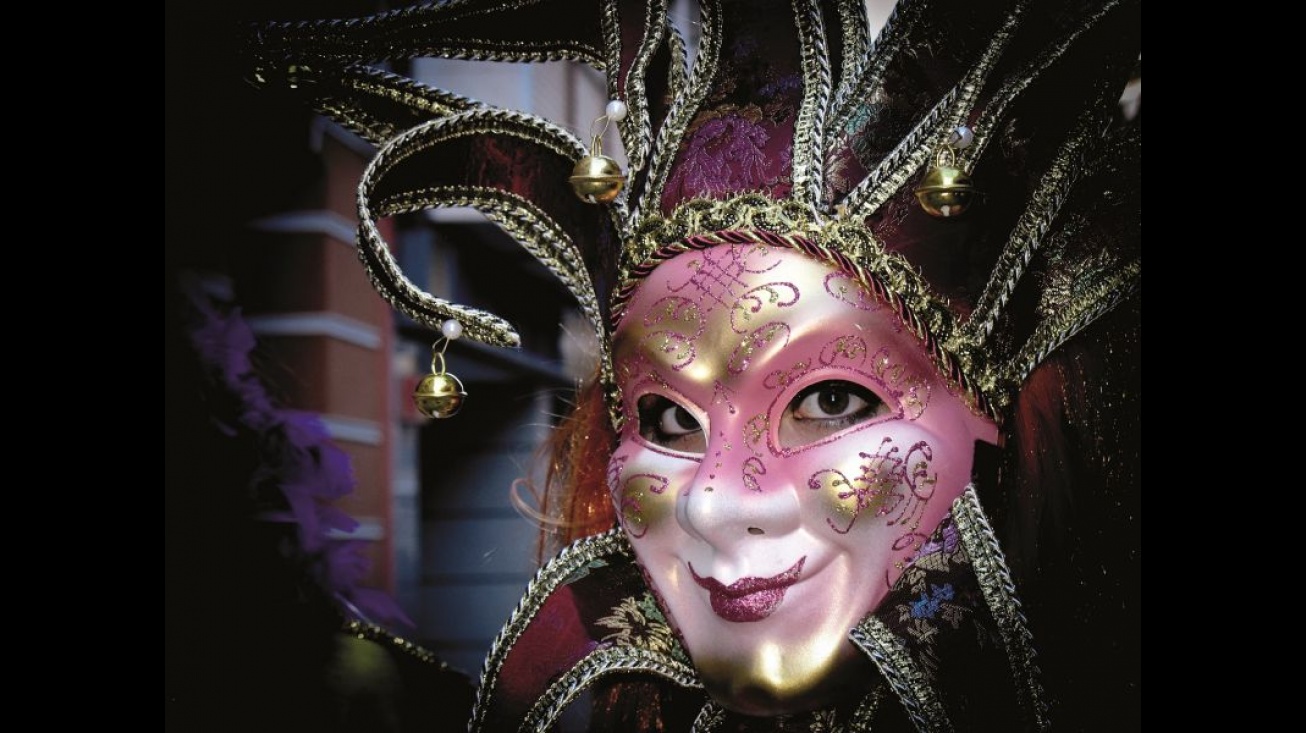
xmin=614 ymin=246 xmax=931 ymax=401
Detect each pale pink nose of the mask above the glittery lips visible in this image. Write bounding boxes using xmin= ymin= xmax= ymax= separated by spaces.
xmin=677 ymin=436 xmax=801 ymax=550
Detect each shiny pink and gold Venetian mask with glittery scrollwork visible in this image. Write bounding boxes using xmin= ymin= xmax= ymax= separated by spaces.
xmin=609 ymin=244 xmax=996 ymax=715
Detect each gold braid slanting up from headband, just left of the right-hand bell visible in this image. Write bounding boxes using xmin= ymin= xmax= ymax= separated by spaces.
xmin=845 ymin=0 xmax=1029 ymax=218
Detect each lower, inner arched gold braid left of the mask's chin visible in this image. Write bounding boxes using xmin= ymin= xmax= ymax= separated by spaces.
xmin=517 ymin=647 xmax=703 ymax=733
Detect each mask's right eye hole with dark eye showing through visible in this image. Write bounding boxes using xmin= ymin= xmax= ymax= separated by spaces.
xmin=780 ymin=379 xmax=893 ymax=448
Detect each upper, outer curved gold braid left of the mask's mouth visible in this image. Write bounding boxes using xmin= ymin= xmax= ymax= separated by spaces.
xmin=468 ymin=529 xmax=633 ymax=730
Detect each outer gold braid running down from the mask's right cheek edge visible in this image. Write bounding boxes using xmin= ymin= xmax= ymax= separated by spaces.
xmin=952 ymin=485 xmax=1049 ymax=730
